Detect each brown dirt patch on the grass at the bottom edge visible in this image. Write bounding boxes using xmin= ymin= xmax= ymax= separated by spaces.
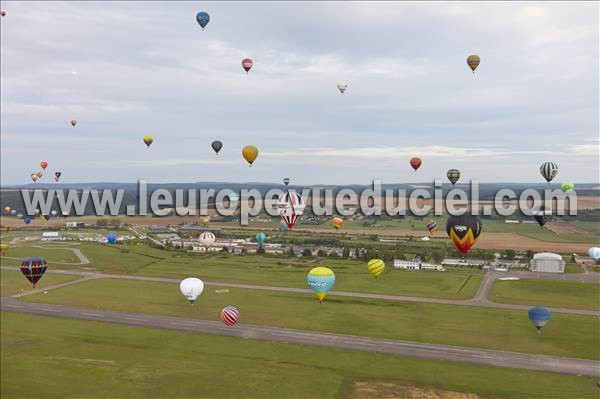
xmin=343 ymin=381 xmax=481 ymax=399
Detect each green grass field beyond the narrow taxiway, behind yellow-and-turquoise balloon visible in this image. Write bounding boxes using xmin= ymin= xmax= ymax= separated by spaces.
xmin=31 ymin=243 xmax=483 ymax=299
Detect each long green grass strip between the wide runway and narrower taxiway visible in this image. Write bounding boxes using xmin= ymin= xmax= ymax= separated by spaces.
xmin=23 ymin=280 xmax=600 ymax=359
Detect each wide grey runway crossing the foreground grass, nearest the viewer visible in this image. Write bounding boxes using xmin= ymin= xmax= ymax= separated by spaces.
xmin=1 ymin=298 xmax=600 ymax=377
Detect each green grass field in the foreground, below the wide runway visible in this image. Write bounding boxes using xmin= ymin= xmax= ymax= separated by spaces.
xmin=1 ymin=312 xmax=598 ymax=399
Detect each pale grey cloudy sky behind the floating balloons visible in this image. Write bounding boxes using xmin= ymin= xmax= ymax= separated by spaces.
xmin=0 ymin=1 xmax=600 ymax=185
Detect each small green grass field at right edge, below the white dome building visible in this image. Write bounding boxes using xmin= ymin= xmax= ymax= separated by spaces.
xmin=489 ymin=279 xmax=600 ymax=310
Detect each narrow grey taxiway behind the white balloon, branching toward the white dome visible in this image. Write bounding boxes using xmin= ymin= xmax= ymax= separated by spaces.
xmin=2 ymin=266 xmax=600 ymax=316
